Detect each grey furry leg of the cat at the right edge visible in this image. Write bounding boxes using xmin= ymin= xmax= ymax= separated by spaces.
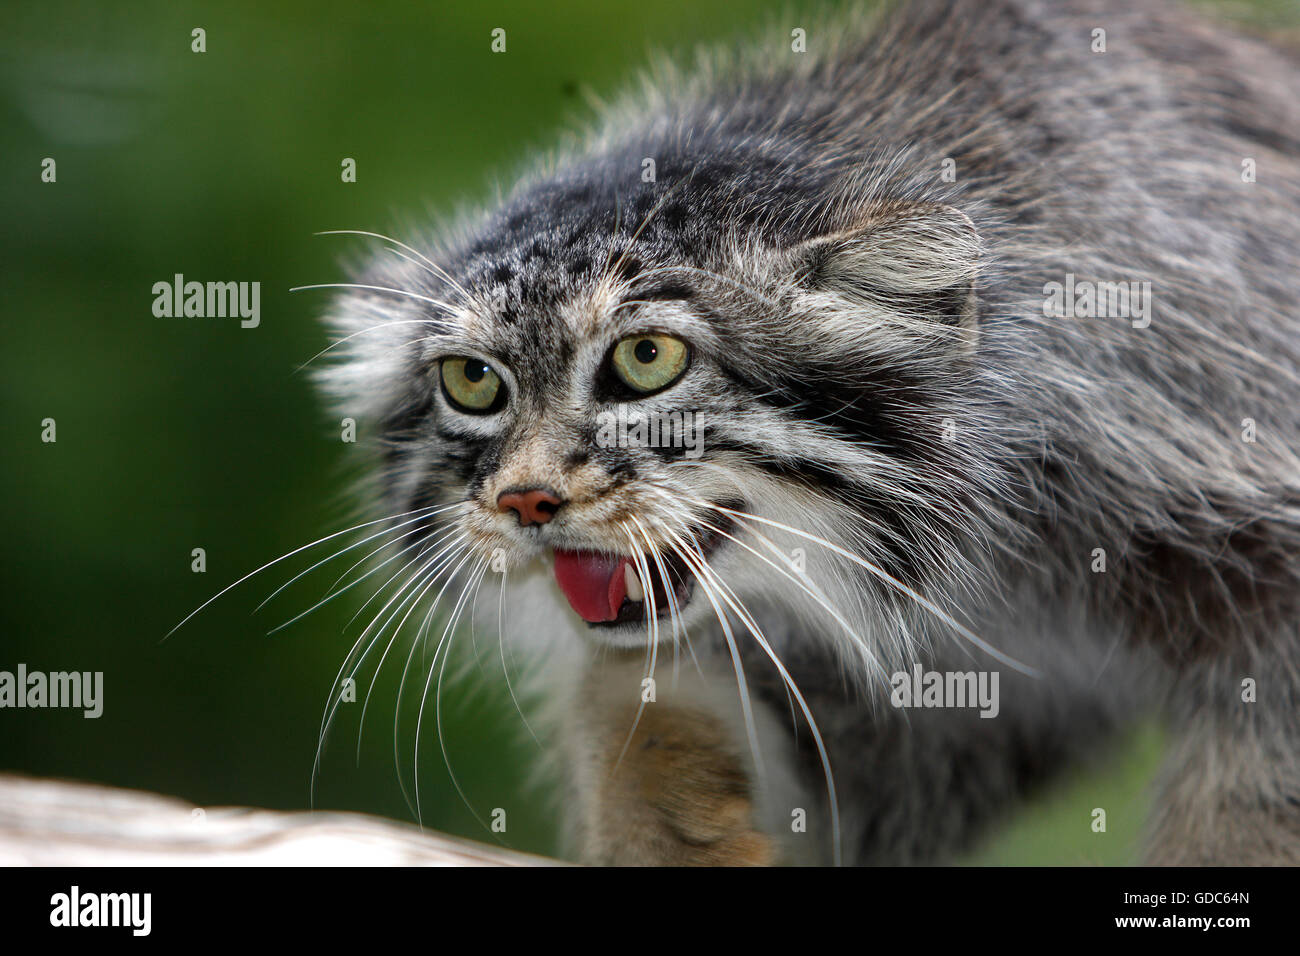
xmin=1147 ymin=653 xmax=1300 ymax=866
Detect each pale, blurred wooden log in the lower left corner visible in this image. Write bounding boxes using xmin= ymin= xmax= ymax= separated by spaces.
xmin=0 ymin=774 xmax=555 ymax=866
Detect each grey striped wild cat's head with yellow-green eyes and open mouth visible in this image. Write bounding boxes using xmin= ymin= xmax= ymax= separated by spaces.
xmin=324 ymin=145 xmax=1008 ymax=676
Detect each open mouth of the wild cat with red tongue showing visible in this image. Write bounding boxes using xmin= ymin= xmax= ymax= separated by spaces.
xmin=555 ymin=522 xmax=729 ymax=627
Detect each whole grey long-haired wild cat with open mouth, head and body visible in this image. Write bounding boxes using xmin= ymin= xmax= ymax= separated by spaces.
xmin=319 ymin=0 xmax=1300 ymax=862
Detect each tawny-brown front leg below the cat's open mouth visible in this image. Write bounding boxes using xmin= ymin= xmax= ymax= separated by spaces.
xmin=564 ymin=652 xmax=811 ymax=866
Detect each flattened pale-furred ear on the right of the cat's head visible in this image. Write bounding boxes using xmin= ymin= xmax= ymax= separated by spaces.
xmin=797 ymin=202 xmax=983 ymax=332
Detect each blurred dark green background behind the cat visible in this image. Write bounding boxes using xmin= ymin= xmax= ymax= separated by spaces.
xmin=0 ymin=0 xmax=1300 ymax=864
